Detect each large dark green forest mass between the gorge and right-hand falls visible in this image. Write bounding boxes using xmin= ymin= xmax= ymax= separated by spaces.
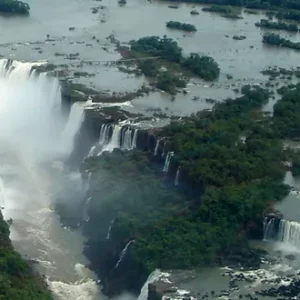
xmin=79 ymin=86 xmax=300 ymax=294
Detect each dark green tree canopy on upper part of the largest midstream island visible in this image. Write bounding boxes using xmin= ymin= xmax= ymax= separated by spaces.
xmin=130 ymin=36 xmax=220 ymax=81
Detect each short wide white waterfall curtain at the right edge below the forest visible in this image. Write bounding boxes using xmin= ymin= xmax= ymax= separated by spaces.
xmin=278 ymin=219 xmax=300 ymax=249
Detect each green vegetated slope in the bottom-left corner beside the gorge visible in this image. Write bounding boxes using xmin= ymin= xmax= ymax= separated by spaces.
xmin=0 ymin=214 xmax=52 ymax=300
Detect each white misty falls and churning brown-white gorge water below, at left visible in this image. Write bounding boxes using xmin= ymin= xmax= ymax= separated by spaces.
xmin=0 ymin=59 xmax=100 ymax=300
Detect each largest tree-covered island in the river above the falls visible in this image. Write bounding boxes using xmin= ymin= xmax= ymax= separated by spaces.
xmin=119 ymin=36 xmax=220 ymax=94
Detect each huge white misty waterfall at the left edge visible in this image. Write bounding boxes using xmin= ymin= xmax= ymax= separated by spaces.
xmin=0 ymin=59 xmax=83 ymax=160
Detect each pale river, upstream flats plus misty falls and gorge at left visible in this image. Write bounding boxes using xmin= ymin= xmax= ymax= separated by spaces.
xmin=0 ymin=0 xmax=300 ymax=300
